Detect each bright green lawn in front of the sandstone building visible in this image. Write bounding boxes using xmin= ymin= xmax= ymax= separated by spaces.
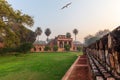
xmin=0 ymin=52 xmax=81 ymax=80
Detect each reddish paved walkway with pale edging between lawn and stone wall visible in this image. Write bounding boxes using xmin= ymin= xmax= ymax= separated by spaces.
xmin=62 ymin=55 xmax=91 ymax=80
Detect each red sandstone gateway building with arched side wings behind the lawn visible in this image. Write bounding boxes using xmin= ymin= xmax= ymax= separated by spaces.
xmin=31 ymin=35 xmax=81 ymax=52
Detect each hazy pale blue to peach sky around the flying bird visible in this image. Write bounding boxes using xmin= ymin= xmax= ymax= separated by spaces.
xmin=7 ymin=0 xmax=120 ymax=42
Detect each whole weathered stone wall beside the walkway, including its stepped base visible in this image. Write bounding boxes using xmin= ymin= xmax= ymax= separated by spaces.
xmin=85 ymin=26 xmax=120 ymax=80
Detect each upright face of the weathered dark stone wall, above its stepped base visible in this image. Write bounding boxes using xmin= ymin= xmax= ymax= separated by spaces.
xmin=85 ymin=26 xmax=120 ymax=80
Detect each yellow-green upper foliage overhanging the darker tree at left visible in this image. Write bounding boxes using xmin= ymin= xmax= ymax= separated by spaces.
xmin=0 ymin=0 xmax=34 ymax=26
